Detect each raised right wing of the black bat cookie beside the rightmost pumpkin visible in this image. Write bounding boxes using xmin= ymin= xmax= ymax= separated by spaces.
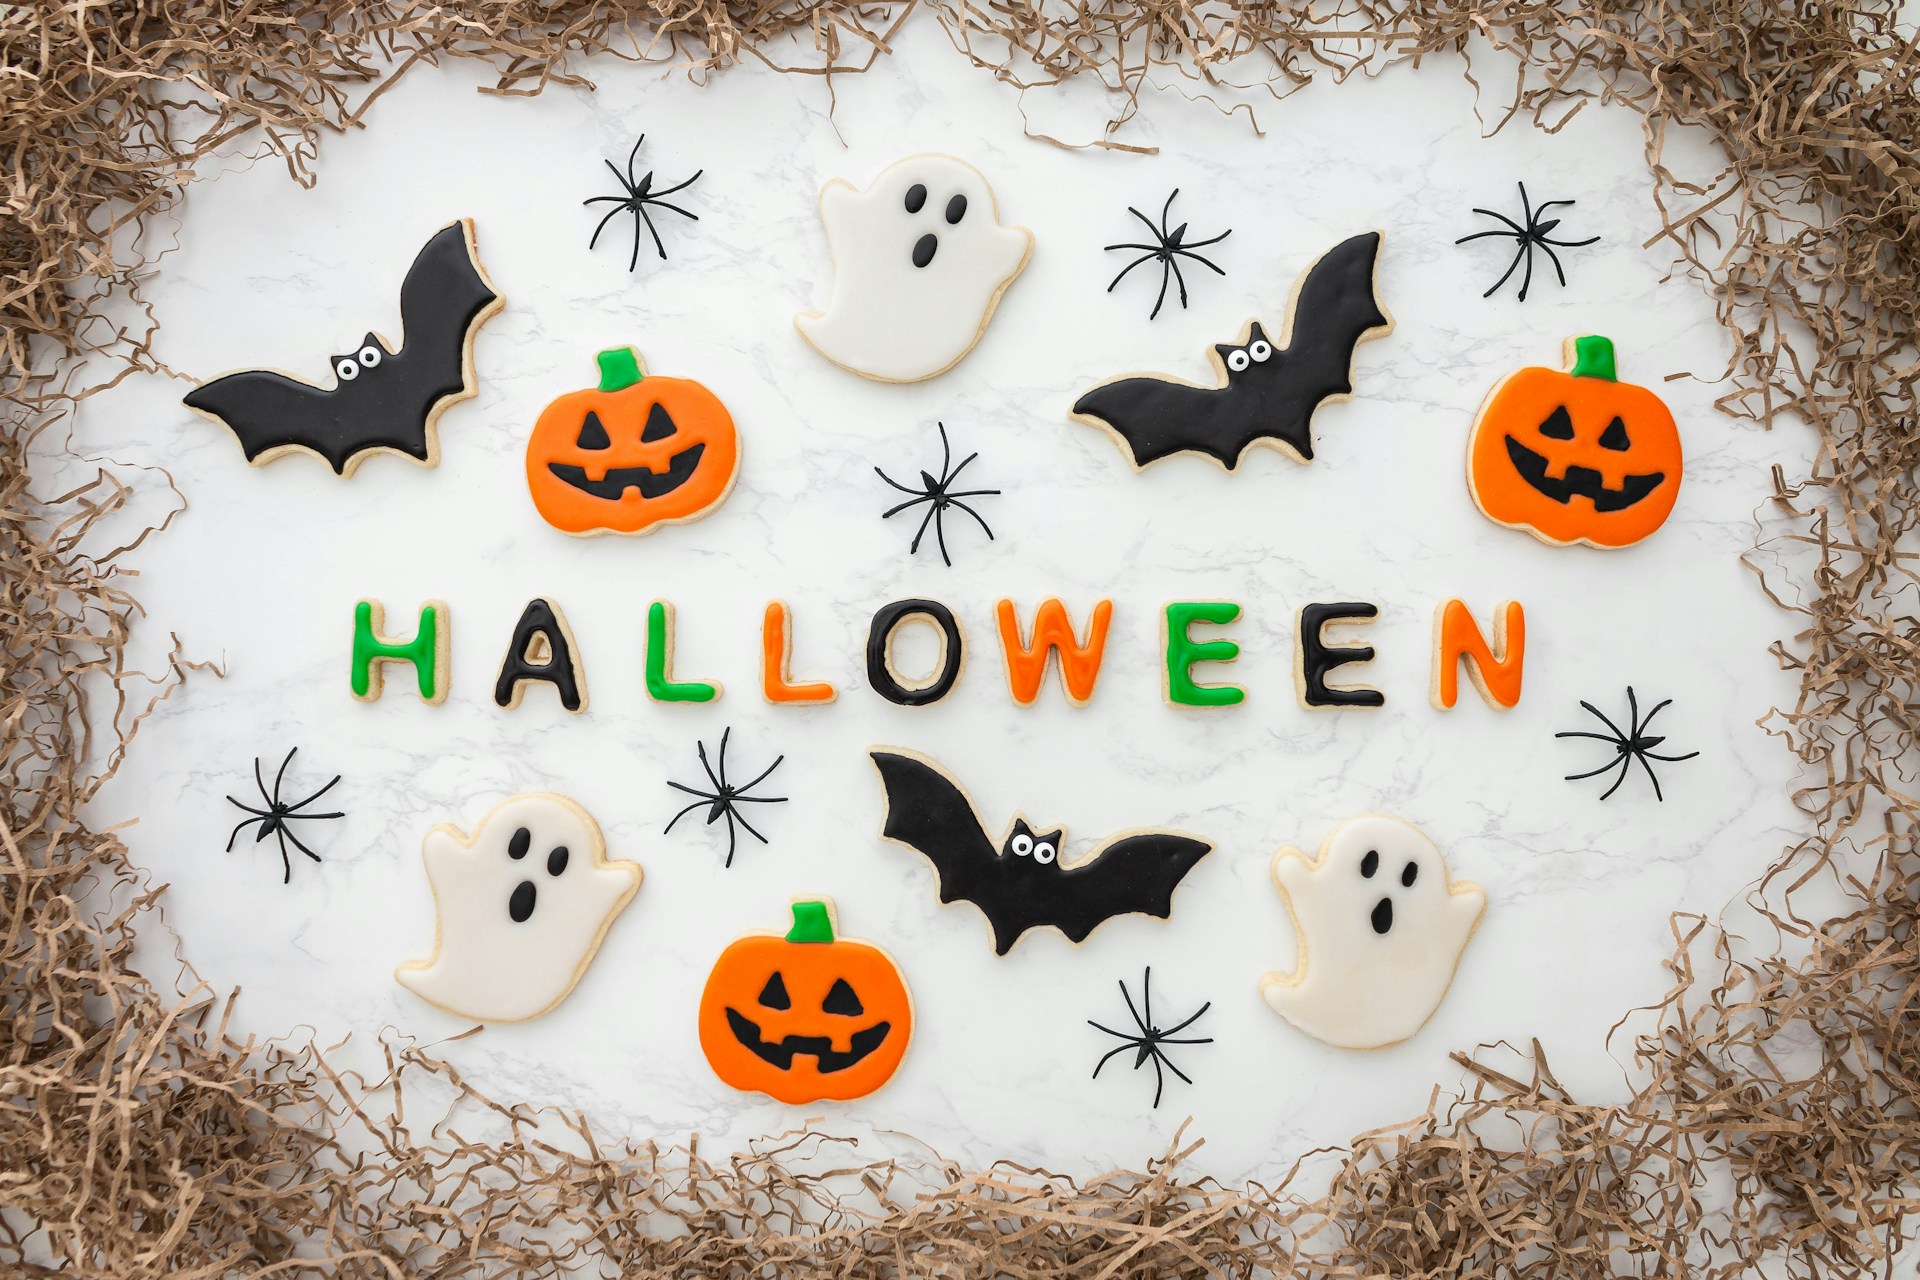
xmin=1240 ymin=230 xmax=1394 ymax=461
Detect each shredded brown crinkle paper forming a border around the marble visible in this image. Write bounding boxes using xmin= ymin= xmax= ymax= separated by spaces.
xmin=0 ymin=0 xmax=1920 ymax=1280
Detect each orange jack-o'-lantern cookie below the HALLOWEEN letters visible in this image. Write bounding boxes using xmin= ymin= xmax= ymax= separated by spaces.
xmin=699 ymin=898 xmax=914 ymax=1103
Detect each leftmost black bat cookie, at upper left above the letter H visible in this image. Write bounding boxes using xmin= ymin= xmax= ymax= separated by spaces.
xmin=184 ymin=219 xmax=503 ymax=476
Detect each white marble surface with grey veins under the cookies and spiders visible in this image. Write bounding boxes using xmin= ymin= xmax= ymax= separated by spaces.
xmin=77 ymin=23 xmax=1805 ymax=1176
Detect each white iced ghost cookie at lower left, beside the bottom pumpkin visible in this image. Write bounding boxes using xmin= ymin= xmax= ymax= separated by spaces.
xmin=394 ymin=793 xmax=639 ymax=1023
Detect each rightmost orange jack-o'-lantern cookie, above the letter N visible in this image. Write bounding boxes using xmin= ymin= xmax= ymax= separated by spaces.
xmin=1467 ymin=336 xmax=1682 ymax=547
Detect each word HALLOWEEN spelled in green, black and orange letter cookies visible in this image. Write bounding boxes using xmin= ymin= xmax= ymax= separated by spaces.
xmin=349 ymin=599 xmax=1526 ymax=712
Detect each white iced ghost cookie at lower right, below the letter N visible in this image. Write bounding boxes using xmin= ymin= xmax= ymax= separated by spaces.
xmin=1260 ymin=814 xmax=1486 ymax=1050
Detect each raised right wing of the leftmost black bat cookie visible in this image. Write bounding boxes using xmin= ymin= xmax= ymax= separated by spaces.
xmin=376 ymin=219 xmax=501 ymax=462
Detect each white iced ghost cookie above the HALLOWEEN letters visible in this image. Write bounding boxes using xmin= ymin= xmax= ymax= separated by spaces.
xmin=793 ymin=155 xmax=1033 ymax=382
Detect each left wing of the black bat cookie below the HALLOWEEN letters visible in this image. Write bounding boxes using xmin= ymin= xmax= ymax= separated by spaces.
xmin=870 ymin=750 xmax=1025 ymax=940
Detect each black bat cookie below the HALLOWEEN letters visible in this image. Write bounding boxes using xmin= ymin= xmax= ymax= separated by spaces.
xmin=870 ymin=748 xmax=1213 ymax=956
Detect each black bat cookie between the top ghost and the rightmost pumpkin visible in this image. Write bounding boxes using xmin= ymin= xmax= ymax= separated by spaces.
xmin=1071 ymin=230 xmax=1394 ymax=470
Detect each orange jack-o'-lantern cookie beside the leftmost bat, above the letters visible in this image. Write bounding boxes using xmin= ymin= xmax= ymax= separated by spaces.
xmin=526 ymin=347 xmax=739 ymax=537
